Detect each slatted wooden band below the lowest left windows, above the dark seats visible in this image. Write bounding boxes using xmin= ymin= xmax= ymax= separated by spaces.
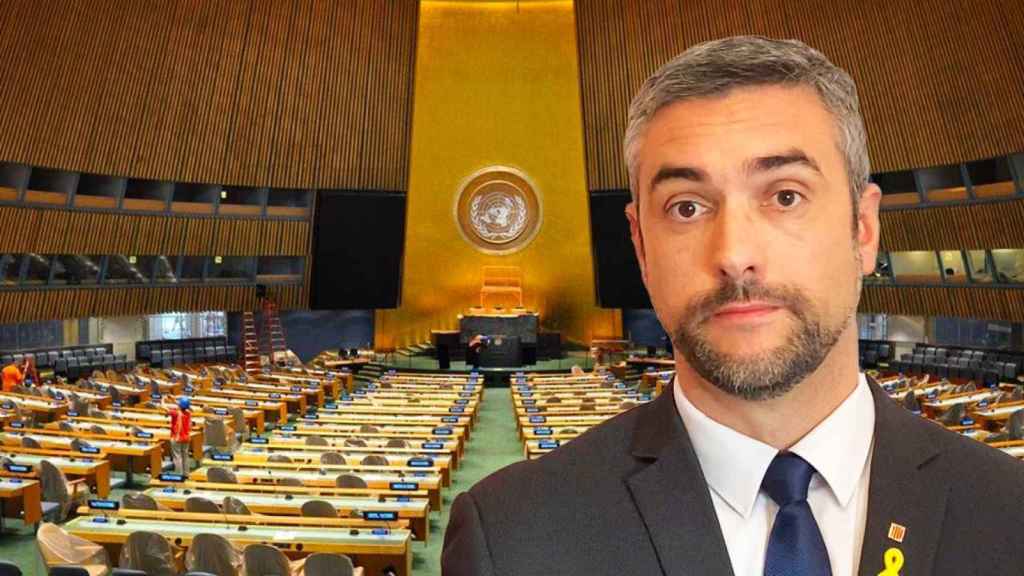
xmin=0 ymin=285 xmax=308 ymax=323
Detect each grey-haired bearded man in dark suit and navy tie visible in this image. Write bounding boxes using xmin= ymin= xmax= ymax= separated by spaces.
xmin=441 ymin=37 xmax=1024 ymax=576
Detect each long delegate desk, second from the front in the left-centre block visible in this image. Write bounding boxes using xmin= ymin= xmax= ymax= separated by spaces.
xmin=145 ymin=487 xmax=430 ymax=542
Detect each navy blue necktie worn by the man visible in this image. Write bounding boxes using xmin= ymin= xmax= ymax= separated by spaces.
xmin=761 ymin=453 xmax=831 ymax=576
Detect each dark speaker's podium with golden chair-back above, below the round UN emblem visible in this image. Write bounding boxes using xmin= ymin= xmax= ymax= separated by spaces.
xmin=459 ymin=266 xmax=540 ymax=368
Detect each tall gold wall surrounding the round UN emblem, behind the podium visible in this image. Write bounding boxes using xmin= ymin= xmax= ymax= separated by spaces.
xmin=376 ymin=0 xmax=622 ymax=346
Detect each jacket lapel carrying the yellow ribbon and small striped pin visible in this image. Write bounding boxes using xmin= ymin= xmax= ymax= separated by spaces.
xmin=859 ymin=383 xmax=950 ymax=576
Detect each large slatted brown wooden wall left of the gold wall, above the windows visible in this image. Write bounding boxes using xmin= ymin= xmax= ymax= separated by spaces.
xmin=0 ymin=0 xmax=419 ymax=190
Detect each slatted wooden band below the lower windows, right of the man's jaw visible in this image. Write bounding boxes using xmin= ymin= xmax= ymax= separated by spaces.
xmin=859 ymin=285 xmax=1024 ymax=322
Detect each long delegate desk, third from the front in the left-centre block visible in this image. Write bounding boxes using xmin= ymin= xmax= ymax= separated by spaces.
xmin=188 ymin=462 xmax=441 ymax=509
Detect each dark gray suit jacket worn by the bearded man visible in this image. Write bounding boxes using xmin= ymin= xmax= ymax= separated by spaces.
xmin=441 ymin=384 xmax=1024 ymax=576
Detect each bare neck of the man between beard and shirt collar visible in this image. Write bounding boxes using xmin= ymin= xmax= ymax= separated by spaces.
xmin=675 ymin=325 xmax=859 ymax=450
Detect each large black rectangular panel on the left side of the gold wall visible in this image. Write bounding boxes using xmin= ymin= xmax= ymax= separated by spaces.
xmin=309 ymin=190 xmax=406 ymax=310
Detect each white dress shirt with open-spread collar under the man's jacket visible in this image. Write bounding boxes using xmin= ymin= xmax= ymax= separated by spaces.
xmin=672 ymin=374 xmax=874 ymax=576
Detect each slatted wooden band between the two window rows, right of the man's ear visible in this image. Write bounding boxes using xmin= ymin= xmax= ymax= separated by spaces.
xmin=881 ymin=200 xmax=1024 ymax=251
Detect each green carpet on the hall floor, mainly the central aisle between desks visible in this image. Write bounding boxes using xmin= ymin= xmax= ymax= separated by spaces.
xmin=0 ymin=388 xmax=522 ymax=576
